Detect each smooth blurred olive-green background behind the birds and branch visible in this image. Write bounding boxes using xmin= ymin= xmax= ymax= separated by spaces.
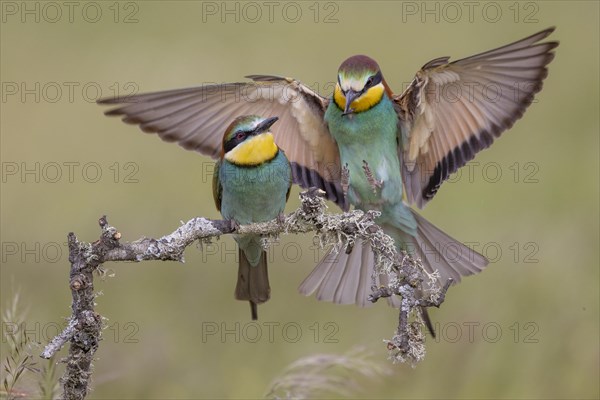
xmin=0 ymin=1 xmax=600 ymax=399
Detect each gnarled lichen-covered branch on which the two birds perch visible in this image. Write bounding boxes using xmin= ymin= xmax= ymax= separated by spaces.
xmin=41 ymin=189 xmax=448 ymax=399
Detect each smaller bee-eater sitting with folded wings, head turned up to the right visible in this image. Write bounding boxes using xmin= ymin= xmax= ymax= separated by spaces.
xmin=213 ymin=115 xmax=292 ymax=320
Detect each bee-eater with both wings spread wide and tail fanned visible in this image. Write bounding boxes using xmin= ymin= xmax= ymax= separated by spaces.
xmin=101 ymin=28 xmax=558 ymax=326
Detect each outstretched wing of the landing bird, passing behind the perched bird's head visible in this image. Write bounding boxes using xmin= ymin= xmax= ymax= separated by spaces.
xmin=98 ymin=75 xmax=348 ymax=209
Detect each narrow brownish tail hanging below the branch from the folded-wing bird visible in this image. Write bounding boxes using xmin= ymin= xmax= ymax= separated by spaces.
xmin=235 ymin=249 xmax=271 ymax=320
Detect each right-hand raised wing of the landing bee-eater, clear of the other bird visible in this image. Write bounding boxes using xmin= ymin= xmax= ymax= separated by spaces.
xmin=393 ymin=28 xmax=558 ymax=208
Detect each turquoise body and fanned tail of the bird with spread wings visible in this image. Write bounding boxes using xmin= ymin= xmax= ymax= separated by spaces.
xmin=324 ymin=71 xmax=487 ymax=336
